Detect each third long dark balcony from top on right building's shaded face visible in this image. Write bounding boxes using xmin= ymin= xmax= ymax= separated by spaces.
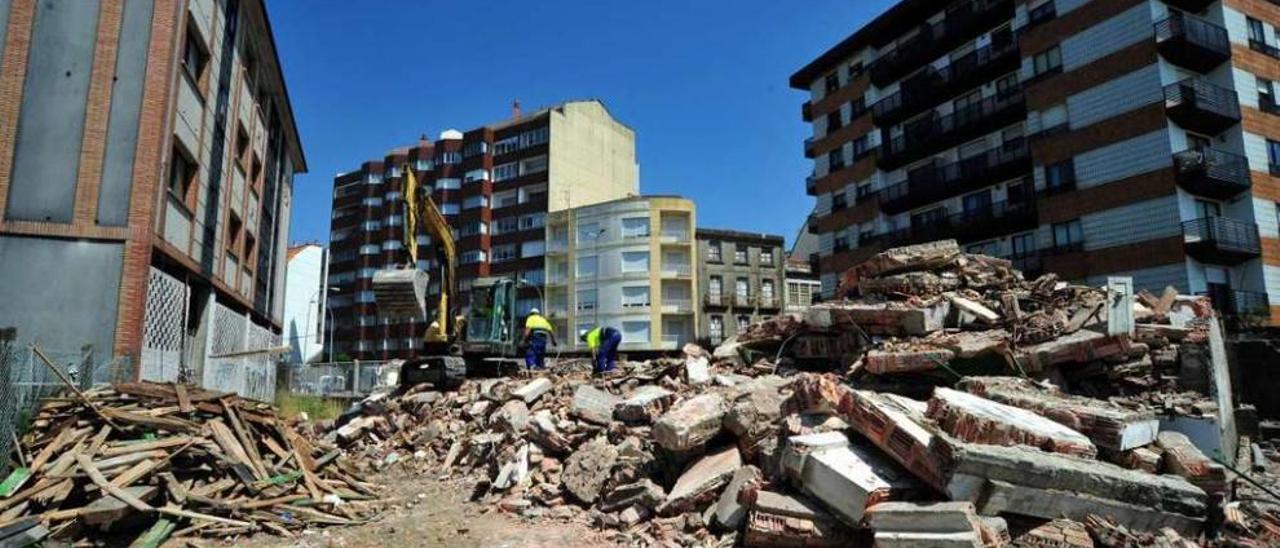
xmin=879 ymin=87 xmax=1027 ymax=170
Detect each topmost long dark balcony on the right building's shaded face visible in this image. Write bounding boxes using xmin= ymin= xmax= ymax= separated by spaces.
xmin=870 ymin=0 xmax=1014 ymax=87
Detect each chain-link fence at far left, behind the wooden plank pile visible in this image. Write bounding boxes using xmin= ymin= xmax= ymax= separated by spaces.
xmin=0 ymin=330 xmax=134 ymax=472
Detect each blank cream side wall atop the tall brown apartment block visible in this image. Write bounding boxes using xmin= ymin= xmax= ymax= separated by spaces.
xmin=547 ymin=101 xmax=640 ymax=211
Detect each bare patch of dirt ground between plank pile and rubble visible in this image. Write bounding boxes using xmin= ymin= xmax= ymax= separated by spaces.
xmin=224 ymin=472 xmax=613 ymax=548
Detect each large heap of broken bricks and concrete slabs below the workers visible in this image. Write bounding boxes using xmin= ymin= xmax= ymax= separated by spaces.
xmin=317 ymin=242 xmax=1280 ymax=547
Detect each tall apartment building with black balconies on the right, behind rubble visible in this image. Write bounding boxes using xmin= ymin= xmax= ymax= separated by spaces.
xmin=791 ymin=0 xmax=1280 ymax=324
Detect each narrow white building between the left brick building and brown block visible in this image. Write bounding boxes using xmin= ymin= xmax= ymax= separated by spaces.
xmin=284 ymin=243 xmax=329 ymax=364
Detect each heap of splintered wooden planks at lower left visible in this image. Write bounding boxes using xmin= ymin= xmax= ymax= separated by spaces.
xmin=0 ymin=383 xmax=380 ymax=545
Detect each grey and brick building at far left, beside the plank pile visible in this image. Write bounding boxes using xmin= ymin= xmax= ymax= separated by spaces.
xmin=0 ymin=0 xmax=306 ymax=396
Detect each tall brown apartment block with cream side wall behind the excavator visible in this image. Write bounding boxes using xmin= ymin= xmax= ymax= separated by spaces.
xmin=329 ymin=100 xmax=639 ymax=360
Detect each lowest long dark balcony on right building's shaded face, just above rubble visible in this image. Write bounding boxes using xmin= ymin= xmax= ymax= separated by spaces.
xmin=876 ymin=200 xmax=1038 ymax=247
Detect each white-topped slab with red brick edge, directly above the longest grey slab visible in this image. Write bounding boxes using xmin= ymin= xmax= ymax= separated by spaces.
xmin=925 ymin=387 xmax=1098 ymax=458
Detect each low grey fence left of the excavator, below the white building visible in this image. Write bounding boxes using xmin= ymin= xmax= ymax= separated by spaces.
xmin=282 ymin=361 xmax=401 ymax=397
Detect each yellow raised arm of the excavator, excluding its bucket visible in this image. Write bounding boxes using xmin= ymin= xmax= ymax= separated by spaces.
xmin=404 ymin=164 xmax=461 ymax=343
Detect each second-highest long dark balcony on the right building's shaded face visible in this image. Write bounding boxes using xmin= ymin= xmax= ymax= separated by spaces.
xmin=872 ymin=41 xmax=1021 ymax=127
